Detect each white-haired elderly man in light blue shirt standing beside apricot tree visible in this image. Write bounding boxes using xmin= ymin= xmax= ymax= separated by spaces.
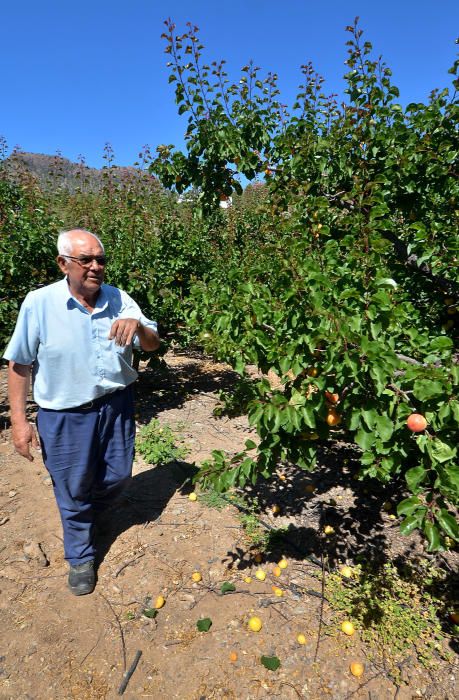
xmin=5 ymin=229 xmax=159 ymax=595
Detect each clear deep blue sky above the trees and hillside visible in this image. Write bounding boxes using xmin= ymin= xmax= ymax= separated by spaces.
xmin=0 ymin=0 xmax=459 ymax=167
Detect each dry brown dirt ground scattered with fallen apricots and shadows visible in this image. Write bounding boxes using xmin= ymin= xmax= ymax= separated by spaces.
xmin=0 ymin=355 xmax=459 ymax=700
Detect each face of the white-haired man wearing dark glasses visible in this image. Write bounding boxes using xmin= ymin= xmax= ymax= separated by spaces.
xmin=57 ymin=231 xmax=105 ymax=296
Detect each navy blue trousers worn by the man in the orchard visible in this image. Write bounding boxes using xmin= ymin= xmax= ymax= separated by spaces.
xmin=37 ymin=387 xmax=135 ymax=565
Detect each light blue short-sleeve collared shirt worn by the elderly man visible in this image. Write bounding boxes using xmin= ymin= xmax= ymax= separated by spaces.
xmin=4 ymin=278 xmax=157 ymax=410
